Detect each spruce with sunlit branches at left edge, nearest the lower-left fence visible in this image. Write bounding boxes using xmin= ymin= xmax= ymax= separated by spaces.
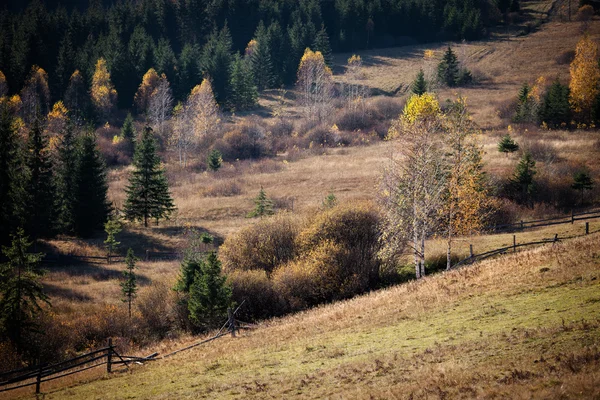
xmin=0 ymin=228 xmax=50 ymax=351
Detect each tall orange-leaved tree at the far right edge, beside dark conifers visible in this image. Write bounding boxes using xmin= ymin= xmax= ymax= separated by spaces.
xmin=569 ymin=34 xmax=600 ymax=121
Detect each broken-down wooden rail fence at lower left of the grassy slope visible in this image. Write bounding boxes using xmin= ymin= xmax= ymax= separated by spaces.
xmin=0 ymin=301 xmax=254 ymax=394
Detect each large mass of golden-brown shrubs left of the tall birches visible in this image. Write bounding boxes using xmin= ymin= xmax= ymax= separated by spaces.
xmin=220 ymin=204 xmax=379 ymax=318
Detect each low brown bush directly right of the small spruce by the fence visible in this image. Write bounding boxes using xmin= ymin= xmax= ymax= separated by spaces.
xmin=227 ymin=270 xmax=287 ymax=321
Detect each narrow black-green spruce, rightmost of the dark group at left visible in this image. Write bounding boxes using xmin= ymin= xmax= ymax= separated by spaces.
xmin=74 ymin=134 xmax=111 ymax=237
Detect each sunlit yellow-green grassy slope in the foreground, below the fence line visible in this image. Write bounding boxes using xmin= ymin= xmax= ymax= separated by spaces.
xmin=46 ymin=234 xmax=600 ymax=399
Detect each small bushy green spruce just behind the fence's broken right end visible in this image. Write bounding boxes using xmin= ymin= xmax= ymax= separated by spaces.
xmin=188 ymin=252 xmax=231 ymax=330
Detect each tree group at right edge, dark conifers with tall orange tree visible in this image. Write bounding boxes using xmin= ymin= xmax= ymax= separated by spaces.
xmin=513 ymin=34 xmax=600 ymax=128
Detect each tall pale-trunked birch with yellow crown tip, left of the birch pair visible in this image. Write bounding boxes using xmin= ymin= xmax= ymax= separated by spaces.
xmin=379 ymin=111 xmax=445 ymax=279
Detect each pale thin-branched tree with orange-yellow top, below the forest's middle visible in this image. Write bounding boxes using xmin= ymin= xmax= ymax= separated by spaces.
xmin=296 ymin=48 xmax=333 ymax=121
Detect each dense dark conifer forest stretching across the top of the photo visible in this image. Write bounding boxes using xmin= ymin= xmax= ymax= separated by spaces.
xmin=0 ymin=0 xmax=499 ymax=112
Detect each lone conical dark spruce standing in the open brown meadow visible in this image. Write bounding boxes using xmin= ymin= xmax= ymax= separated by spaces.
xmin=124 ymin=127 xmax=175 ymax=227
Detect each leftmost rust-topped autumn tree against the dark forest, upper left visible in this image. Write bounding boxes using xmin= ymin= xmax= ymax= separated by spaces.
xmin=21 ymin=65 xmax=50 ymax=123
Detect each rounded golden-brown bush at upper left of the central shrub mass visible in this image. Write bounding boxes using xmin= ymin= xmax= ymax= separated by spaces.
xmin=219 ymin=214 xmax=300 ymax=275
